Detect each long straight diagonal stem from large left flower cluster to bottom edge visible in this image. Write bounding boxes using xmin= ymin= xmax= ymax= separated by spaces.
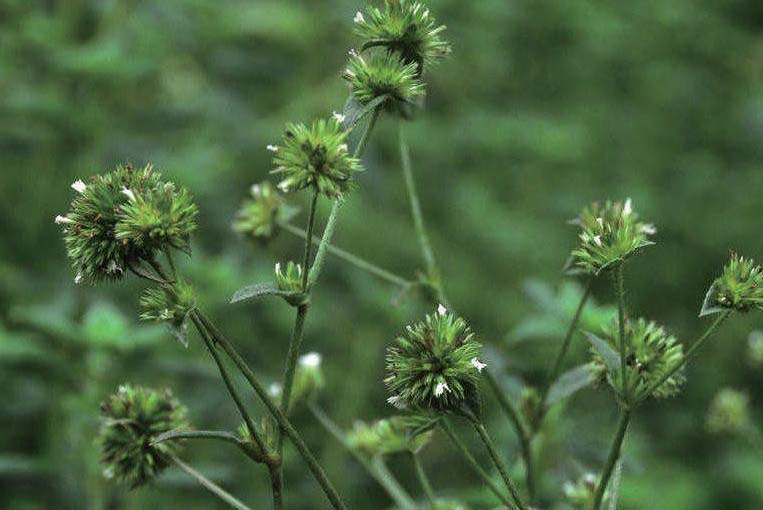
xmin=199 ymin=313 xmax=347 ymax=510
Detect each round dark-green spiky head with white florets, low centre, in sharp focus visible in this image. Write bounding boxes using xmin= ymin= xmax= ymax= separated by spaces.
xmin=384 ymin=305 xmax=484 ymax=411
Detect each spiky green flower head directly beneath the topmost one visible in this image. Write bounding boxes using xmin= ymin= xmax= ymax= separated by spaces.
xmin=342 ymin=53 xmax=425 ymax=113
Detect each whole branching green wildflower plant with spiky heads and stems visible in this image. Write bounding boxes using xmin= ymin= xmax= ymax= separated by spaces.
xmin=55 ymin=0 xmax=763 ymax=510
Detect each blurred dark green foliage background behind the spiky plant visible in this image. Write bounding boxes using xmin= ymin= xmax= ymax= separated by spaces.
xmin=0 ymin=0 xmax=763 ymax=510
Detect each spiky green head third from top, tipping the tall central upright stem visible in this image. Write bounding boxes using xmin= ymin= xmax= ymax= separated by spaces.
xmin=268 ymin=116 xmax=363 ymax=198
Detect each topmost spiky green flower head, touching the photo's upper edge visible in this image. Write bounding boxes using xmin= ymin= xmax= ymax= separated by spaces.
xmin=354 ymin=0 xmax=451 ymax=72
